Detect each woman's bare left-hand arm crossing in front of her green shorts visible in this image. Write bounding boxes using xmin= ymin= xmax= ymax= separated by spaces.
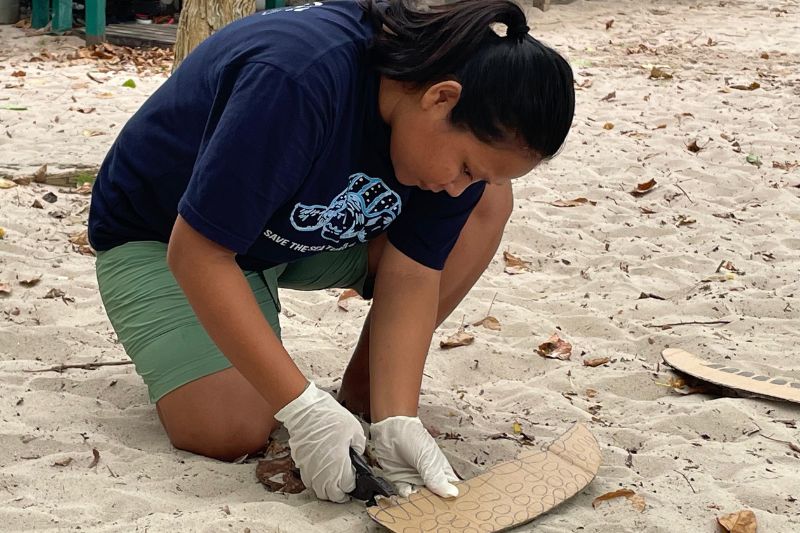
xmin=167 ymin=216 xmax=307 ymax=411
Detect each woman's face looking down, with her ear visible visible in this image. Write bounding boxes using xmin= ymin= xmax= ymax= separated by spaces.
xmin=382 ymin=81 xmax=541 ymax=196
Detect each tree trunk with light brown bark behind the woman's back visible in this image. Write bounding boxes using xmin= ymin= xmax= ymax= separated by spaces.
xmin=172 ymin=0 xmax=256 ymax=71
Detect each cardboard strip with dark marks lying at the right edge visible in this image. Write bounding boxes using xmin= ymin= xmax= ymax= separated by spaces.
xmin=661 ymin=348 xmax=800 ymax=403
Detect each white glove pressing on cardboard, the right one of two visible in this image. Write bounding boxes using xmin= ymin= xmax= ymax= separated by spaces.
xmin=370 ymin=416 xmax=458 ymax=498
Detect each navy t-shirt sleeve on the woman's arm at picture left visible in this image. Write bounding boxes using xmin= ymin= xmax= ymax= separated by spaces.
xmin=178 ymin=63 xmax=325 ymax=254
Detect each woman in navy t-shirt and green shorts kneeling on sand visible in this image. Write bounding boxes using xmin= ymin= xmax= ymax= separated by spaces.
xmin=89 ymin=0 xmax=574 ymax=502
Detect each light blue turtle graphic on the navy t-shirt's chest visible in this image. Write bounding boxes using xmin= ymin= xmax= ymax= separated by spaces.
xmin=290 ymin=173 xmax=402 ymax=243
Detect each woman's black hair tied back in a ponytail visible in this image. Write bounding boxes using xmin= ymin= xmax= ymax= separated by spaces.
xmin=358 ymin=0 xmax=575 ymax=159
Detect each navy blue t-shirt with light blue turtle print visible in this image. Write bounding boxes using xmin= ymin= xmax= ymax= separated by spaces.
xmin=89 ymin=0 xmax=484 ymax=270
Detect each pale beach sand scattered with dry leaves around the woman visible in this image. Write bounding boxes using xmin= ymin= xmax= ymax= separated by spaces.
xmin=0 ymin=0 xmax=800 ymax=533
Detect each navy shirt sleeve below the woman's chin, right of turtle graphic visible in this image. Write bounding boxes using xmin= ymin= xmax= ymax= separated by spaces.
xmin=389 ymin=182 xmax=486 ymax=270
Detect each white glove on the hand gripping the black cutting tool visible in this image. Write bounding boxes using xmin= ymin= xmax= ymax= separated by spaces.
xmin=275 ymin=382 xmax=367 ymax=503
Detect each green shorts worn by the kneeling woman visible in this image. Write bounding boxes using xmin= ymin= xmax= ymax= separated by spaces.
xmin=97 ymin=241 xmax=372 ymax=403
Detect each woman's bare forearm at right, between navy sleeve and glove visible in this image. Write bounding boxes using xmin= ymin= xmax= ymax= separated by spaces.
xmin=369 ymin=242 xmax=441 ymax=422
